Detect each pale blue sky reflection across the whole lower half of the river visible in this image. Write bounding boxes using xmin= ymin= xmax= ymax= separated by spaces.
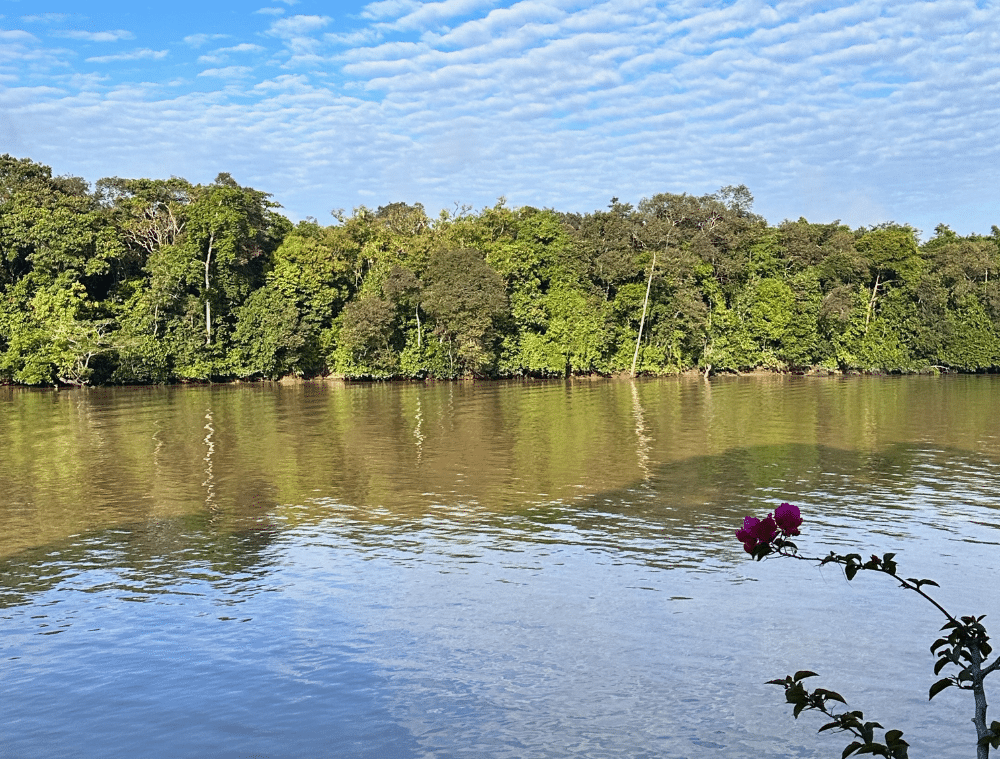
xmin=0 ymin=486 xmax=1000 ymax=759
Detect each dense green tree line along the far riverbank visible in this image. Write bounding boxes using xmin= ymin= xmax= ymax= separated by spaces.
xmin=0 ymin=155 xmax=1000 ymax=385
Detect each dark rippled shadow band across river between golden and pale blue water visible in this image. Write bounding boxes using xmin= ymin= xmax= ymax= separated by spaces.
xmin=0 ymin=436 xmax=1000 ymax=607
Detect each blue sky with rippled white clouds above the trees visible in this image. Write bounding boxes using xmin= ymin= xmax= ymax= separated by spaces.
xmin=0 ymin=0 xmax=1000 ymax=239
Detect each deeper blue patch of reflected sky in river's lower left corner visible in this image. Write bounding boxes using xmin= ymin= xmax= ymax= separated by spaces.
xmin=0 ymin=543 xmax=416 ymax=759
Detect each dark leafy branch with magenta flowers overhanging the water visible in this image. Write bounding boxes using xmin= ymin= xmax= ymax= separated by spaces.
xmin=736 ymin=503 xmax=1000 ymax=759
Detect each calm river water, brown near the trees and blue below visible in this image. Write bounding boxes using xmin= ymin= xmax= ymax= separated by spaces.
xmin=0 ymin=377 xmax=1000 ymax=759
